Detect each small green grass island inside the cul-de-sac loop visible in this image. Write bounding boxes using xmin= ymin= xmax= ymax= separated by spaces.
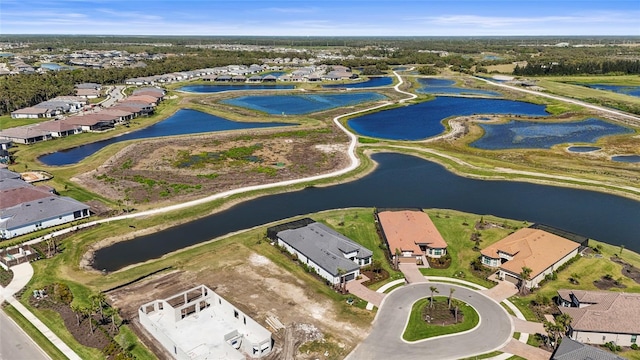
xmin=402 ymin=296 xmax=480 ymax=341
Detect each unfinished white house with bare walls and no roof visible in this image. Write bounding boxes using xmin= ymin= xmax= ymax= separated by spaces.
xmin=138 ymin=285 xmax=273 ymax=360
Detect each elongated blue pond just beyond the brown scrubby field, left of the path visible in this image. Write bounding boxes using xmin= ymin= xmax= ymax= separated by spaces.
xmin=221 ymin=92 xmax=387 ymax=115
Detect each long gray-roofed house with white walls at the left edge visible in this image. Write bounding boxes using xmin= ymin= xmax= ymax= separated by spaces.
xmin=0 ymin=195 xmax=90 ymax=239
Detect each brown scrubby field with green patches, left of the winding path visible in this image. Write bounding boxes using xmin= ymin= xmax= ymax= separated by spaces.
xmin=73 ymin=126 xmax=348 ymax=205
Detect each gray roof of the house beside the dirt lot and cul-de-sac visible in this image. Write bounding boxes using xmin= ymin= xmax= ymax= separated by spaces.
xmin=277 ymin=222 xmax=373 ymax=276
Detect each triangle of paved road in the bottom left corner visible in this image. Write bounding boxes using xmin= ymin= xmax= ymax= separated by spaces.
xmin=0 ymin=311 xmax=49 ymax=360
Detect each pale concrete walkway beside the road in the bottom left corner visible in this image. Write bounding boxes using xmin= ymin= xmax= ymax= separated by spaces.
xmin=0 ymin=263 xmax=82 ymax=360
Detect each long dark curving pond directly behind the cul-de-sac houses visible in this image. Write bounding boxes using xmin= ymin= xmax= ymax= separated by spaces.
xmin=94 ymin=153 xmax=640 ymax=271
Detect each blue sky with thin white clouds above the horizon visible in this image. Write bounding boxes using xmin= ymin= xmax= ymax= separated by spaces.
xmin=0 ymin=0 xmax=640 ymax=36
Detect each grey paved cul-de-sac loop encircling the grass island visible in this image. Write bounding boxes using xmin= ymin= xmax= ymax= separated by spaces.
xmin=347 ymin=283 xmax=513 ymax=360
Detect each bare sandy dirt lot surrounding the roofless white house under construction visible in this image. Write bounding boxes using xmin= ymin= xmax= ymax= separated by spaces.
xmin=107 ymin=243 xmax=373 ymax=359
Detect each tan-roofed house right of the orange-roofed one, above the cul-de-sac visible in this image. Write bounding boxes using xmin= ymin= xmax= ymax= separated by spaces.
xmin=480 ymin=228 xmax=580 ymax=289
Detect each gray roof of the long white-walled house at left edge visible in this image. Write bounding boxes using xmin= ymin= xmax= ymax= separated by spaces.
xmin=0 ymin=195 xmax=89 ymax=230
